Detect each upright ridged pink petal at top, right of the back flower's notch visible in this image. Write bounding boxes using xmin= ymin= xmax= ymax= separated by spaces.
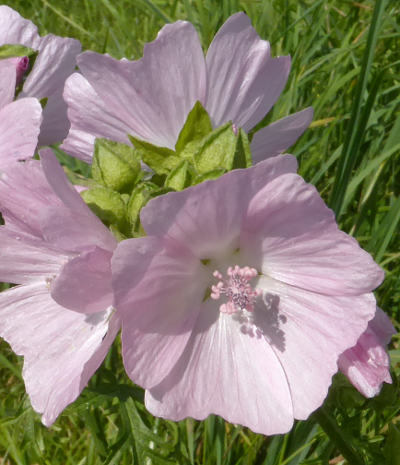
xmin=206 ymin=13 xmax=290 ymax=131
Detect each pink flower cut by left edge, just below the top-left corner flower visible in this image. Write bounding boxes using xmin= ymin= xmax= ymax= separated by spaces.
xmin=0 ymin=59 xmax=42 ymax=172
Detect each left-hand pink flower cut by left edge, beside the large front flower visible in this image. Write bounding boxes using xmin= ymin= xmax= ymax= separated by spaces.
xmin=0 ymin=150 xmax=119 ymax=426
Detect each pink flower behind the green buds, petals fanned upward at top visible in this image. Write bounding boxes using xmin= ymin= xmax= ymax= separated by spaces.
xmin=62 ymin=13 xmax=312 ymax=163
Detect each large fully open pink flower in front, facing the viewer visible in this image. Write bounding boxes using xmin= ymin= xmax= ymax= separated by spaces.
xmin=112 ymin=155 xmax=383 ymax=434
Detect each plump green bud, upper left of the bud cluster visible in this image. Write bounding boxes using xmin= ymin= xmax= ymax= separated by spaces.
xmin=92 ymin=139 xmax=141 ymax=193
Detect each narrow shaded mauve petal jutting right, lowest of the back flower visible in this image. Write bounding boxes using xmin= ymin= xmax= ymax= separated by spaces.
xmin=251 ymin=107 xmax=313 ymax=163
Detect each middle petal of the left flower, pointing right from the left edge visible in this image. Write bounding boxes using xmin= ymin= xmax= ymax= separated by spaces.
xmin=0 ymin=226 xmax=71 ymax=284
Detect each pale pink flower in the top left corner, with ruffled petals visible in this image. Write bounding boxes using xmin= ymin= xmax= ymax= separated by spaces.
xmin=0 ymin=5 xmax=81 ymax=145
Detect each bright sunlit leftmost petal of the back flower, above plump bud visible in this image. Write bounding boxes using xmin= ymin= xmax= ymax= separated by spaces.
xmin=61 ymin=73 xmax=130 ymax=163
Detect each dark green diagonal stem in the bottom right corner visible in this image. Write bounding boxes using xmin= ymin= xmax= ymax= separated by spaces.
xmin=314 ymin=407 xmax=365 ymax=465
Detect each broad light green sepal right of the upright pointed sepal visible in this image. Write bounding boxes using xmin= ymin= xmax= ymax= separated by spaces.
xmin=194 ymin=122 xmax=236 ymax=173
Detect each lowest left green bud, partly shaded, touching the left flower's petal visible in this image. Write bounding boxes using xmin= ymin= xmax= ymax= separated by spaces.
xmin=81 ymin=187 xmax=129 ymax=233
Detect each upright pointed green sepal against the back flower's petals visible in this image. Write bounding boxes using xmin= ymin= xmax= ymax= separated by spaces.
xmin=175 ymin=101 xmax=212 ymax=154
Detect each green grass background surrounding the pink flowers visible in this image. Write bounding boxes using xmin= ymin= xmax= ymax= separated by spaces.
xmin=0 ymin=0 xmax=400 ymax=465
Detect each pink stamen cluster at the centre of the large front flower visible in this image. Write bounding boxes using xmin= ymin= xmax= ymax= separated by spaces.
xmin=210 ymin=265 xmax=262 ymax=314
